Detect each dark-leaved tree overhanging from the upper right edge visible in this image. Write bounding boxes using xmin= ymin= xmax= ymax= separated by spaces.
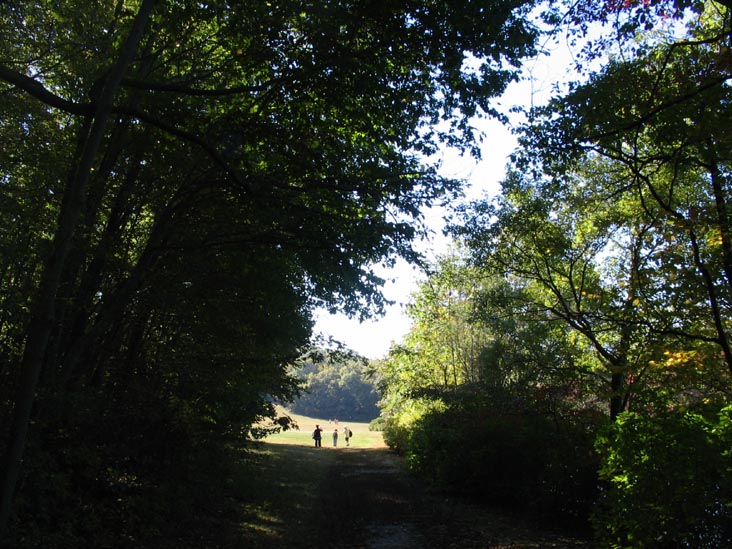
xmin=522 ymin=3 xmax=732 ymax=376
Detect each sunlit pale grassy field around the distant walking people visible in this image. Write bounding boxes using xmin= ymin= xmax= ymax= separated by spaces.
xmin=264 ymin=410 xmax=384 ymax=448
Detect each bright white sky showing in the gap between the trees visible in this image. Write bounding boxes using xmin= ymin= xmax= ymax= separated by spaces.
xmin=315 ymin=37 xmax=571 ymax=359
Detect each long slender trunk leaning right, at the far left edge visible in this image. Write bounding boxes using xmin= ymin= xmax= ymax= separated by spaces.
xmin=0 ymin=0 xmax=156 ymax=533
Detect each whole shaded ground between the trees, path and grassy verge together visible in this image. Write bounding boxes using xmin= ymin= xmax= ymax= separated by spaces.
xmin=234 ymin=424 xmax=594 ymax=549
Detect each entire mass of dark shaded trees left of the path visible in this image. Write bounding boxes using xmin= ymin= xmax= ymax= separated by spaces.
xmin=0 ymin=0 xmax=535 ymax=546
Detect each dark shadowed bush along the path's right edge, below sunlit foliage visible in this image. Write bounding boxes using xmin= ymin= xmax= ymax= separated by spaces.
xmin=403 ymin=402 xmax=598 ymax=524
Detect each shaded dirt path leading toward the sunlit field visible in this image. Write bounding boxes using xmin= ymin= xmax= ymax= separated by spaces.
xmin=312 ymin=448 xmax=587 ymax=549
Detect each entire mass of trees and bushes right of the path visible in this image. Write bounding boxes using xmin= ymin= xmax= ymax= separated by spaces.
xmin=382 ymin=2 xmax=732 ymax=548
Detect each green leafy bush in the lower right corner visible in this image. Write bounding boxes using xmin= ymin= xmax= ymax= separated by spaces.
xmin=594 ymin=406 xmax=732 ymax=548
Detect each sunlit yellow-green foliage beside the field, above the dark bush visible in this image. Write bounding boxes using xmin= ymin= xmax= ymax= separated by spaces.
xmin=379 ymin=248 xmax=596 ymax=427
